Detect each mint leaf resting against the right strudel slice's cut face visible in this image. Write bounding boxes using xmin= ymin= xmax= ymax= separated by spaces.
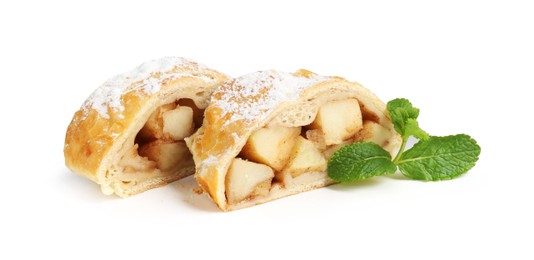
xmin=328 ymin=142 xmax=397 ymax=182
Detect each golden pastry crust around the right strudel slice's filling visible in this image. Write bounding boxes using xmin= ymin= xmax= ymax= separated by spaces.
xmin=186 ymin=70 xmax=400 ymax=210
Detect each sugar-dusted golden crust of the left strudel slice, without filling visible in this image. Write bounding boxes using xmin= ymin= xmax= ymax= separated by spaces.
xmin=64 ymin=57 xmax=228 ymax=197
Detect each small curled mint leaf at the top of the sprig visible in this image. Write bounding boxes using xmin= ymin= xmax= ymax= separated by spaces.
xmin=387 ymin=98 xmax=419 ymax=138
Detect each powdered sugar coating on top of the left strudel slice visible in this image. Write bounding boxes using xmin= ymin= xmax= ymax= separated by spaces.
xmin=82 ymin=57 xmax=214 ymax=118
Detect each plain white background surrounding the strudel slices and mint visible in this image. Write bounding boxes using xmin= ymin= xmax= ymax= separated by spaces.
xmin=0 ymin=0 xmax=534 ymax=259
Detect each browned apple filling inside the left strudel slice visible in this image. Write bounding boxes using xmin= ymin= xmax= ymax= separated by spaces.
xmin=115 ymin=99 xmax=203 ymax=184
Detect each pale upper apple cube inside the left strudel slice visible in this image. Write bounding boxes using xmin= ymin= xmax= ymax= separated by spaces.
xmin=162 ymin=106 xmax=194 ymax=141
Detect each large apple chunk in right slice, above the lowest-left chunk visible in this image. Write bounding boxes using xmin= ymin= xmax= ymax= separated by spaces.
xmin=241 ymin=126 xmax=301 ymax=171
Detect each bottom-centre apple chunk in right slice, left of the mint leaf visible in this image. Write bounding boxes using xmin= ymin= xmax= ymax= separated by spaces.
xmin=282 ymin=136 xmax=326 ymax=177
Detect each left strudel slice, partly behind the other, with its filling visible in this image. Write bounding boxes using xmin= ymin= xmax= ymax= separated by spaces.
xmin=64 ymin=57 xmax=228 ymax=197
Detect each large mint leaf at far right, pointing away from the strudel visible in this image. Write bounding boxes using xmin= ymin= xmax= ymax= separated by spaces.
xmin=397 ymin=134 xmax=480 ymax=181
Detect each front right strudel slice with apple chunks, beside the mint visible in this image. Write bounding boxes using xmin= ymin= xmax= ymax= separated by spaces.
xmin=185 ymin=70 xmax=401 ymax=210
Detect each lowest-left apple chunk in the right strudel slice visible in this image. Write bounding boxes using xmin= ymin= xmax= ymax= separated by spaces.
xmin=226 ymin=158 xmax=274 ymax=204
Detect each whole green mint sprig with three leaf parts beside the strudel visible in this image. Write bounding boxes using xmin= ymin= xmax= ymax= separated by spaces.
xmin=328 ymin=98 xmax=480 ymax=182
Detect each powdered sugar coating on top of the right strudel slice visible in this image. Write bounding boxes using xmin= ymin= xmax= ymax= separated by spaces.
xmin=213 ymin=70 xmax=331 ymax=124
